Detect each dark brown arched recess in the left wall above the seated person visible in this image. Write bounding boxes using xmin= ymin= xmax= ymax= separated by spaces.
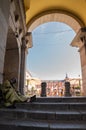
xmin=3 ymin=27 xmax=19 ymax=87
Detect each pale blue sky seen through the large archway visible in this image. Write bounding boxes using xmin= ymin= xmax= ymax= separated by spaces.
xmin=27 ymin=22 xmax=81 ymax=80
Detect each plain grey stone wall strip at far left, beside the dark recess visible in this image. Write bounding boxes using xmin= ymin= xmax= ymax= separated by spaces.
xmin=0 ymin=0 xmax=10 ymax=83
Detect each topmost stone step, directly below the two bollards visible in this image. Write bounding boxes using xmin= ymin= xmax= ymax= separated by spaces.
xmin=36 ymin=96 xmax=86 ymax=103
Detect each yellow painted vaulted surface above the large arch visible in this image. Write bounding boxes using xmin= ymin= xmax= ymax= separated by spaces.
xmin=24 ymin=0 xmax=86 ymax=25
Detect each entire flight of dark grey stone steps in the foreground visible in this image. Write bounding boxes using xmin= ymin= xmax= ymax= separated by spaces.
xmin=0 ymin=97 xmax=86 ymax=130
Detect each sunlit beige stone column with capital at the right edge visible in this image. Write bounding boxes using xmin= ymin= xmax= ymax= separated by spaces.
xmin=71 ymin=27 xmax=86 ymax=96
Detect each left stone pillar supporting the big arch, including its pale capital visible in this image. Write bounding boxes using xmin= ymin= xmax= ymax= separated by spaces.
xmin=20 ymin=32 xmax=32 ymax=94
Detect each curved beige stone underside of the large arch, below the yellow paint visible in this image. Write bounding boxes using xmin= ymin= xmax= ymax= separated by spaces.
xmin=28 ymin=12 xmax=81 ymax=33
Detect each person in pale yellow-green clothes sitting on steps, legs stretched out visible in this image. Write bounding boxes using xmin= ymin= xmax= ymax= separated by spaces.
xmin=0 ymin=79 xmax=36 ymax=108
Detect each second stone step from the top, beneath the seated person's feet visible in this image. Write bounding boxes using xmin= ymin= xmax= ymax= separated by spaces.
xmin=16 ymin=102 xmax=86 ymax=110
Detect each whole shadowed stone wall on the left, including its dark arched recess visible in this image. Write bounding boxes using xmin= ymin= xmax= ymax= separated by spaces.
xmin=0 ymin=0 xmax=31 ymax=93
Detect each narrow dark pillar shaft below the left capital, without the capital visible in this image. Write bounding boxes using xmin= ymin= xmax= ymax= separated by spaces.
xmin=19 ymin=38 xmax=27 ymax=94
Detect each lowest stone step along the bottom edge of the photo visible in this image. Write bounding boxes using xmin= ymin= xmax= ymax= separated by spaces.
xmin=0 ymin=120 xmax=86 ymax=130
